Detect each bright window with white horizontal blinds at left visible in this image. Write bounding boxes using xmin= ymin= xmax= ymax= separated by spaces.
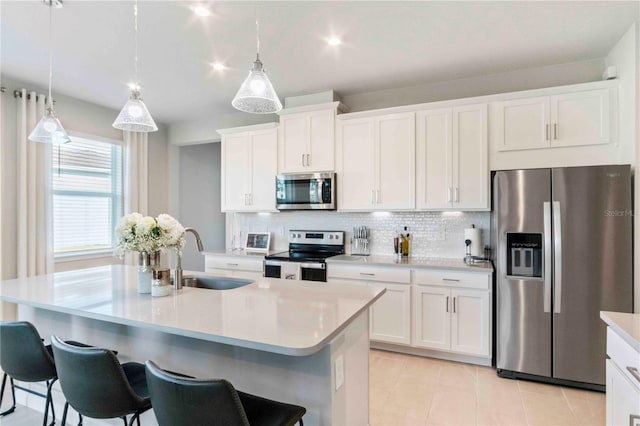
xmin=51 ymin=136 xmax=123 ymax=256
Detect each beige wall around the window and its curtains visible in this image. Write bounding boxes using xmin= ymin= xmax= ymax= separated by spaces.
xmin=0 ymin=76 xmax=169 ymax=279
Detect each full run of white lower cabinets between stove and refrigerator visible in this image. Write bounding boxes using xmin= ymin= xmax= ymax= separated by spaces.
xmin=327 ymin=263 xmax=492 ymax=359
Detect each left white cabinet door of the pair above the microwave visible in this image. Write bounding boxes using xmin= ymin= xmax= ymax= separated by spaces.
xmin=278 ymin=114 xmax=309 ymax=173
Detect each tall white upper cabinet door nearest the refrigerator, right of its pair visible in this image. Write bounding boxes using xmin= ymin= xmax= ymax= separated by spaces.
xmin=452 ymin=104 xmax=491 ymax=210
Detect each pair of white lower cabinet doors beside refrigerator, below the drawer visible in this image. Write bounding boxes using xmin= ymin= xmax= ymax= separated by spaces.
xmin=413 ymin=285 xmax=491 ymax=356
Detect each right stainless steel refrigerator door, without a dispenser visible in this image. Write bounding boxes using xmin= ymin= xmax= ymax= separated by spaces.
xmin=552 ymin=166 xmax=633 ymax=385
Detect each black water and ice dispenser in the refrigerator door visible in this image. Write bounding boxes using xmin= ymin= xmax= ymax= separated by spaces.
xmin=507 ymin=233 xmax=542 ymax=278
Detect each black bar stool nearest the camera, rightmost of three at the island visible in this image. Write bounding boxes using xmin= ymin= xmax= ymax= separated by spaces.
xmin=145 ymin=361 xmax=307 ymax=426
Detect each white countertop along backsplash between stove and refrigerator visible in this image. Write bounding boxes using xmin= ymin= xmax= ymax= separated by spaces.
xmin=327 ymin=254 xmax=493 ymax=273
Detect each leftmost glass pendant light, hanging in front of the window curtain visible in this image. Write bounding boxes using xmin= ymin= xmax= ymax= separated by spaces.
xmin=29 ymin=0 xmax=71 ymax=145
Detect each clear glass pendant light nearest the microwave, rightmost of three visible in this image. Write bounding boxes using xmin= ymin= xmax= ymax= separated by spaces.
xmin=231 ymin=12 xmax=282 ymax=114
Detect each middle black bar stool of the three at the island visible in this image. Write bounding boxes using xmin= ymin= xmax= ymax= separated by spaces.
xmin=51 ymin=336 xmax=151 ymax=426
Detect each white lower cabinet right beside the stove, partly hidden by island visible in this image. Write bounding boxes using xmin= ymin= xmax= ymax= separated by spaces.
xmin=327 ymin=263 xmax=411 ymax=345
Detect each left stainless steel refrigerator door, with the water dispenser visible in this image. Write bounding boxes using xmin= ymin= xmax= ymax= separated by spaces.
xmin=493 ymin=169 xmax=551 ymax=377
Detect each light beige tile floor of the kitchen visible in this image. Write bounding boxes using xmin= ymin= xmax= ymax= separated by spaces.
xmin=0 ymin=350 xmax=605 ymax=426
